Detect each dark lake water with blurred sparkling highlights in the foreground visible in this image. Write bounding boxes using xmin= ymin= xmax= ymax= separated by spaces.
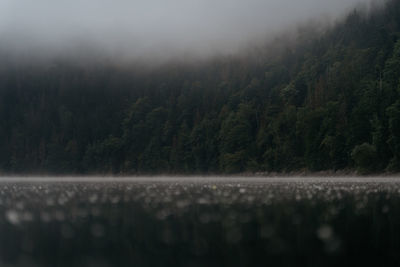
xmin=0 ymin=178 xmax=400 ymax=267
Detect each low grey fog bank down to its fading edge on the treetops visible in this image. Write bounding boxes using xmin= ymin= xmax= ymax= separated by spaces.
xmin=0 ymin=0 xmax=386 ymax=65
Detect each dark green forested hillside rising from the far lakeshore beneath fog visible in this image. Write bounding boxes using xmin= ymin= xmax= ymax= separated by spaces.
xmin=0 ymin=0 xmax=400 ymax=174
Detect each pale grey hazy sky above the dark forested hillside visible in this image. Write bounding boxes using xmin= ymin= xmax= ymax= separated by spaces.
xmin=0 ymin=0 xmax=382 ymax=59
